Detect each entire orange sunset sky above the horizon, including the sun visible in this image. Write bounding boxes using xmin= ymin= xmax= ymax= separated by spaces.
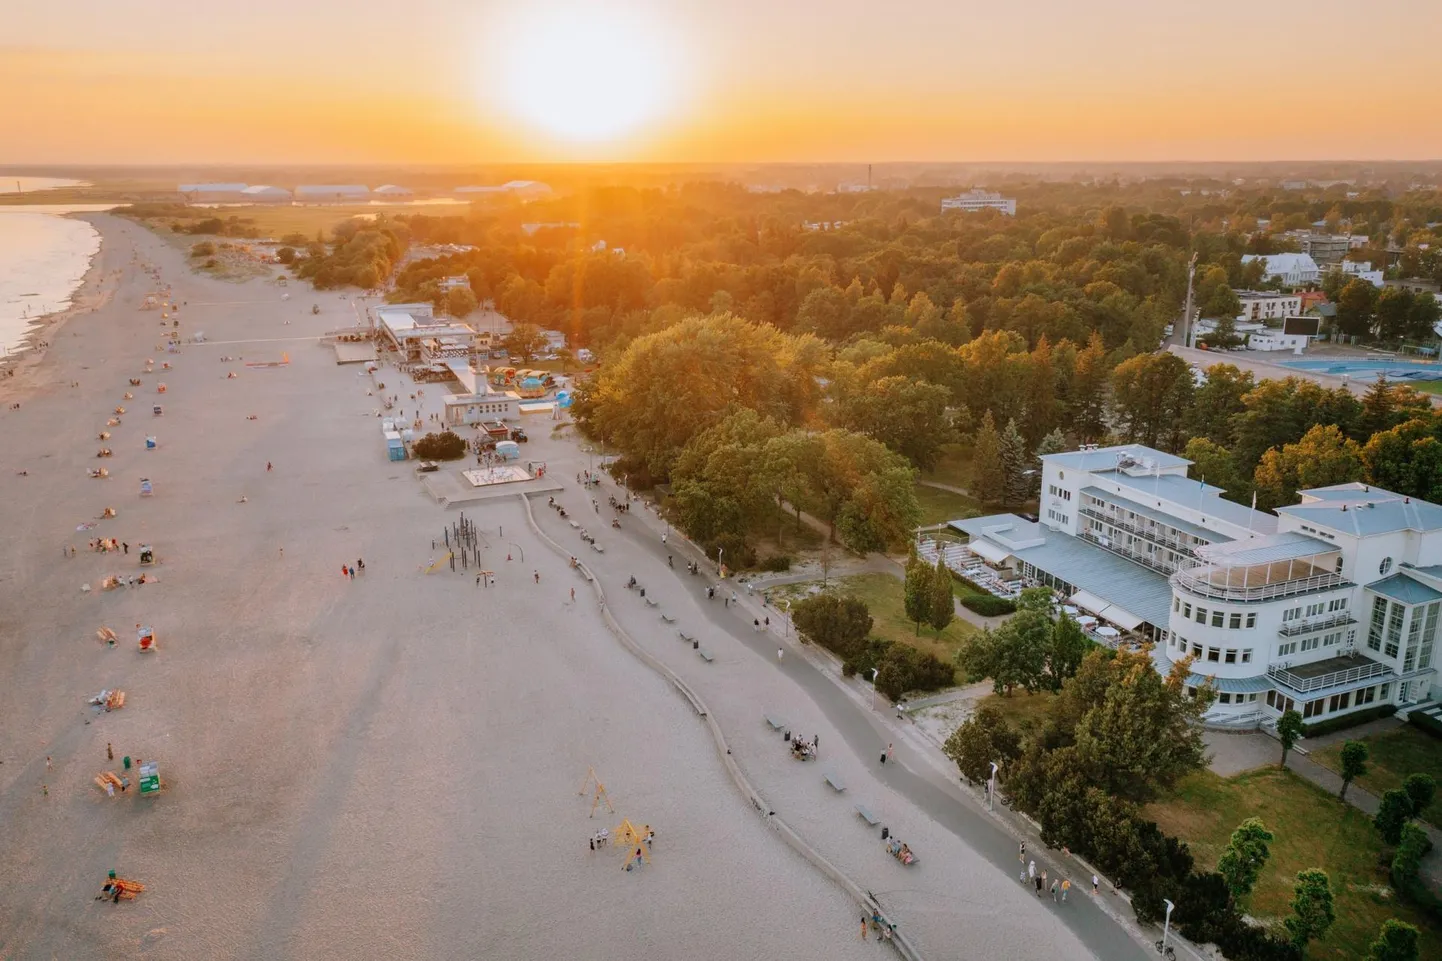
xmin=0 ymin=0 xmax=1442 ymax=163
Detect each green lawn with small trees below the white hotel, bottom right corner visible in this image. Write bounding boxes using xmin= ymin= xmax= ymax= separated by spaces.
xmin=1146 ymin=768 xmax=1442 ymax=961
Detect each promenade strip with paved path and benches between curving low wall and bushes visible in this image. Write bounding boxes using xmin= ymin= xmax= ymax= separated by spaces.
xmin=571 ymin=481 xmax=1156 ymax=961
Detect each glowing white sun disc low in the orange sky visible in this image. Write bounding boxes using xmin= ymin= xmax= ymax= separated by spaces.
xmin=487 ymin=4 xmax=681 ymax=143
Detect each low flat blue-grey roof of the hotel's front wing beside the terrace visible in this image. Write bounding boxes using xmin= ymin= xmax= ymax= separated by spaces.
xmin=950 ymin=514 xmax=1171 ymax=625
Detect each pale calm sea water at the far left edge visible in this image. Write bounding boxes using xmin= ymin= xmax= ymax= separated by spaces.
xmin=0 ymin=177 xmax=111 ymax=354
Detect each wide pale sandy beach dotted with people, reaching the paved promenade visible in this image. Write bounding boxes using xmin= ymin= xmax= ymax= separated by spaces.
xmin=0 ymin=215 xmax=1113 ymax=961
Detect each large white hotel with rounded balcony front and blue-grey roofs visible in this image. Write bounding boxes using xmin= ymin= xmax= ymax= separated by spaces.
xmin=952 ymin=444 xmax=1442 ymax=726
